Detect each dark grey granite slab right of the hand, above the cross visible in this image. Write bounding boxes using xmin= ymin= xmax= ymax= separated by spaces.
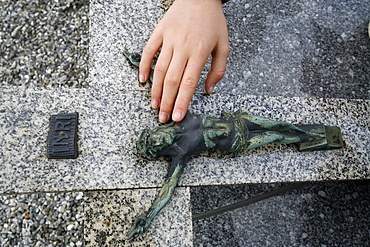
xmin=221 ymin=0 xmax=370 ymax=99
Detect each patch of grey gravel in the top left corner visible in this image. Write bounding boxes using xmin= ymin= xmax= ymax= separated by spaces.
xmin=0 ymin=0 xmax=89 ymax=87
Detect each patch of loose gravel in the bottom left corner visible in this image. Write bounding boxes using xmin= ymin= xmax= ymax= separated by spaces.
xmin=0 ymin=192 xmax=84 ymax=247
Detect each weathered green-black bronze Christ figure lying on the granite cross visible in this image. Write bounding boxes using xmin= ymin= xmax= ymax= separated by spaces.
xmin=128 ymin=111 xmax=344 ymax=238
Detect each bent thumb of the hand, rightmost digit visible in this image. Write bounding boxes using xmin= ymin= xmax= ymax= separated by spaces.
xmin=205 ymin=43 xmax=229 ymax=94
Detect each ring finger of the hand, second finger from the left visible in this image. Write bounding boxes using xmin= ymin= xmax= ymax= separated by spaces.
xmin=151 ymin=47 xmax=173 ymax=109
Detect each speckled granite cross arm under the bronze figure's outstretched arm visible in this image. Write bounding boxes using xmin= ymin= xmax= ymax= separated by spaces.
xmin=84 ymin=188 xmax=193 ymax=246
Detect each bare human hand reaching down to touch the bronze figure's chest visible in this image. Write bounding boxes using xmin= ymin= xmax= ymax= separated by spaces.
xmin=139 ymin=0 xmax=229 ymax=123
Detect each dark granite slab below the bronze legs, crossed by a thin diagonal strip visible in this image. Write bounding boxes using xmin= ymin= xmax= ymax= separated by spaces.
xmin=191 ymin=180 xmax=370 ymax=247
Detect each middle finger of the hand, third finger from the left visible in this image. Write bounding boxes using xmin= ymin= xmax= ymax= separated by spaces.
xmin=159 ymin=54 xmax=187 ymax=123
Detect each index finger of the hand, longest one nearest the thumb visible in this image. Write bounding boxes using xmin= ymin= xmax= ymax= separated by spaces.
xmin=172 ymin=57 xmax=206 ymax=122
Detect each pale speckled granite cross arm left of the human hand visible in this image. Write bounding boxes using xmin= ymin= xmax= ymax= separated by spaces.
xmin=89 ymin=0 xmax=164 ymax=90
